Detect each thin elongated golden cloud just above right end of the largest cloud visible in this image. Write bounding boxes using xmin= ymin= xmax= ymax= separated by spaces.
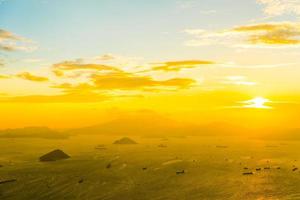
xmin=152 ymin=60 xmax=215 ymax=71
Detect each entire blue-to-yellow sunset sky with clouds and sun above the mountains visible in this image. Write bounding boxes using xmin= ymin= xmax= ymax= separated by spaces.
xmin=0 ymin=0 xmax=300 ymax=128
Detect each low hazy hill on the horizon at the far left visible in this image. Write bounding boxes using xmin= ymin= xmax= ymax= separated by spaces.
xmin=0 ymin=127 xmax=68 ymax=139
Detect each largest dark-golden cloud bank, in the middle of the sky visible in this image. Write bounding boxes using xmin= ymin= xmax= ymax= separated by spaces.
xmin=51 ymin=67 xmax=196 ymax=94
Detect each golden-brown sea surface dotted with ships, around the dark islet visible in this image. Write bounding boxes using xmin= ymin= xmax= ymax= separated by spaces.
xmin=0 ymin=136 xmax=300 ymax=200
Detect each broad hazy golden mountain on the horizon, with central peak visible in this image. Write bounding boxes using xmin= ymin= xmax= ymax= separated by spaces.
xmin=68 ymin=111 xmax=241 ymax=137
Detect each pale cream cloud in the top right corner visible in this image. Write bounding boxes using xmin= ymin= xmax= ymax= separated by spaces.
xmin=257 ymin=0 xmax=300 ymax=16
